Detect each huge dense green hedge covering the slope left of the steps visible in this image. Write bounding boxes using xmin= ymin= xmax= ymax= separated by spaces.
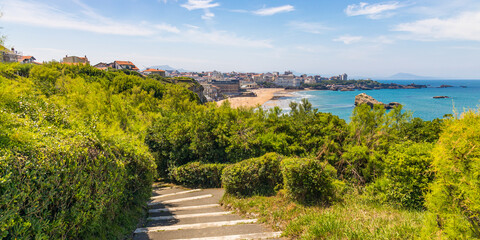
xmin=0 ymin=63 xmax=202 ymax=239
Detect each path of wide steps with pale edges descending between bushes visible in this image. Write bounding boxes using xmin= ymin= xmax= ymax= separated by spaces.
xmin=134 ymin=187 xmax=281 ymax=240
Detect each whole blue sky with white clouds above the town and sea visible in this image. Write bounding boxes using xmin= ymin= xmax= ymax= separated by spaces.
xmin=0 ymin=0 xmax=480 ymax=79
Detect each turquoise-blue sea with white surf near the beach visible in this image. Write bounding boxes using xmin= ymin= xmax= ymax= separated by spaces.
xmin=264 ymin=80 xmax=480 ymax=121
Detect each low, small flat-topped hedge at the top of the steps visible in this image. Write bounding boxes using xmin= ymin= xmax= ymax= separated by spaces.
xmin=170 ymin=162 xmax=227 ymax=188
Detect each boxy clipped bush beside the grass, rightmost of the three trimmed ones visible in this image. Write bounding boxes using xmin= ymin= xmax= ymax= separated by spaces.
xmin=282 ymin=158 xmax=337 ymax=203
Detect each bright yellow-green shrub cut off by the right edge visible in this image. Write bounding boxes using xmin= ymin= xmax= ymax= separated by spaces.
xmin=424 ymin=112 xmax=480 ymax=239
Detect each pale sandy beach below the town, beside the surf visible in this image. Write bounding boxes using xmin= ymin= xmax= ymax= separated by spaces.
xmin=217 ymin=88 xmax=292 ymax=108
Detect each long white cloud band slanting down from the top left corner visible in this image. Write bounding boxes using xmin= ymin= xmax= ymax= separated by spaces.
xmin=2 ymin=0 xmax=273 ymax=48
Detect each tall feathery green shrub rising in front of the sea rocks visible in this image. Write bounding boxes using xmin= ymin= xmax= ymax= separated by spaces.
xmin=342 ymin=104 xmax=410 ymax=186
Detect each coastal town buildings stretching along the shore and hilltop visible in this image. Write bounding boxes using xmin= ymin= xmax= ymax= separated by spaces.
xmin=1 ymin=46 xmax=427 ymax=106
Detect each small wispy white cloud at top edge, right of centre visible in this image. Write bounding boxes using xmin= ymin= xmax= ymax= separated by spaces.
xmin=345 ymin=2 xmax=403 ymax=19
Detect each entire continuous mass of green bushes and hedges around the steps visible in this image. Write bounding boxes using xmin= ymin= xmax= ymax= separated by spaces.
xmin=0 ymin=60 xmax=474 ymax=239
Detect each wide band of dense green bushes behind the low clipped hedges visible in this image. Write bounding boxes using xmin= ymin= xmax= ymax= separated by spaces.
xmin=146 ymin=98 xmax=346 ymax=176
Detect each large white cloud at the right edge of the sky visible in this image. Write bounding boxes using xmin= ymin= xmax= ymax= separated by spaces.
xmin=393 ymin=12 xmax=480 ymax=41
